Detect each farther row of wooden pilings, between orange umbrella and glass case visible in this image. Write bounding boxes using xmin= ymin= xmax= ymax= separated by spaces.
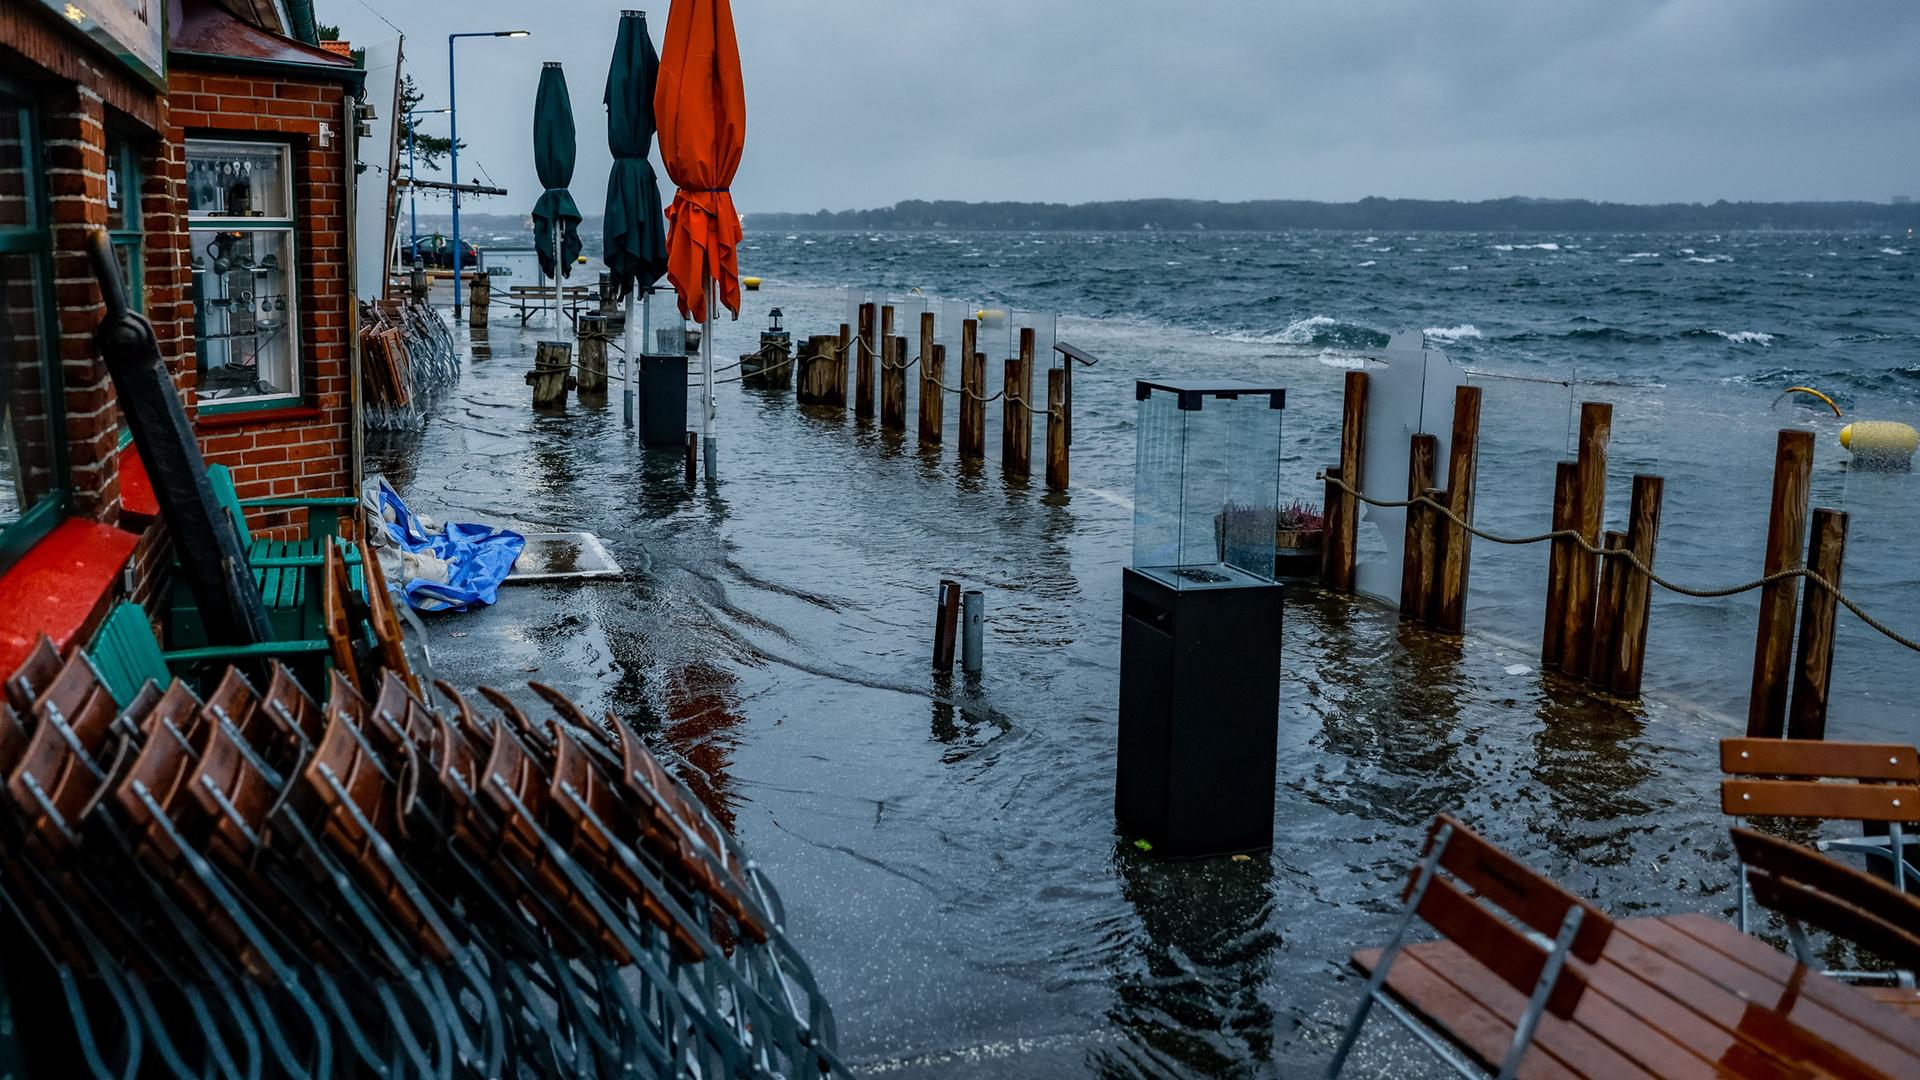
xmin=795 ymin=304 xmax=1071 ymax=490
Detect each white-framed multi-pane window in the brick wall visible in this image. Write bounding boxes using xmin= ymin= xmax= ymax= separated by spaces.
xmin=192 ymin=229 xmax=300 ymax=402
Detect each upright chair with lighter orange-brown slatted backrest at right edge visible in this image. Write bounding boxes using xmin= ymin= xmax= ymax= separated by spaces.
xmin=1720 ymin=738 xmax=1920 ymax=914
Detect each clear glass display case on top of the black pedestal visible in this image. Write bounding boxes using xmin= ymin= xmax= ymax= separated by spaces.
xmin=1133 ymin=380 xmax=1286 ymax=590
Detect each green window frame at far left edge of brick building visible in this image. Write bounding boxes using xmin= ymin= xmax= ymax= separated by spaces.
xmin=0 ymin=77 xmax=73 ymax=571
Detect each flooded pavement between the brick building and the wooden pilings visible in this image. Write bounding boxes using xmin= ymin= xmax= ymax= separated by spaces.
xmin=369 ymin=286 xmax=1889 ymax=1076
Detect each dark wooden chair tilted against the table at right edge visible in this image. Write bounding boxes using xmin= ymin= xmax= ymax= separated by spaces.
xmin=1732 ymin=828 xmax=1920 ymax=1003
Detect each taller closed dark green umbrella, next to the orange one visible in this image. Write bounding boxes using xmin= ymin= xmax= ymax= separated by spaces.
xmin=603 ymin=12 xmax=666 ymax=427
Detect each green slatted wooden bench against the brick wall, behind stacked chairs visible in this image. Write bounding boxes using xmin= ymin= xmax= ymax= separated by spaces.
xmin=167 ymin=465 xmax=367 ymax=646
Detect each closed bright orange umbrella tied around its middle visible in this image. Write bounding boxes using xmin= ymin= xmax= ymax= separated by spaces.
xmin=653 ymin=0 xmax=747 ymax=319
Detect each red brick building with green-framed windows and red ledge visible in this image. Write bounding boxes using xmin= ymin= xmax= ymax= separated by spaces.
xmin=0 ymin=0 xmax=359 ymax=671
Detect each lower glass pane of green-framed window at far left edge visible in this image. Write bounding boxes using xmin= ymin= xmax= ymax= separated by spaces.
xmin=0 ymin=254 xmax=58 ymax=527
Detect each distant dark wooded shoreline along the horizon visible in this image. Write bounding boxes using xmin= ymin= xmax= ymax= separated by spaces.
xmin=420 ymin=198 xmax=1920 ymax=236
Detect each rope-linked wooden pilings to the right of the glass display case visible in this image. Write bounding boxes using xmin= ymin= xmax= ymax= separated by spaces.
xmin=1321 ymin=371 xmax=1847 ymax=738
